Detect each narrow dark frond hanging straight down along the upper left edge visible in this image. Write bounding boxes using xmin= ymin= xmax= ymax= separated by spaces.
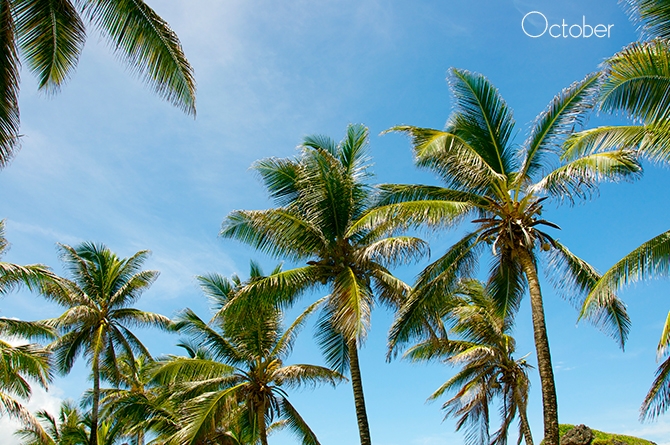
xmin=0 ymin=2 xmax=20 ymax=168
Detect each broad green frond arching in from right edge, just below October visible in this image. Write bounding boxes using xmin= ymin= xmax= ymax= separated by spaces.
xmin=600 ymin=40 xmax=670 ymax=124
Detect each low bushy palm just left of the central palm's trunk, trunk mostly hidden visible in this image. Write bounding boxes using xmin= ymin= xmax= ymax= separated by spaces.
xmin=155 ymin=264 xmax=344 ymax=445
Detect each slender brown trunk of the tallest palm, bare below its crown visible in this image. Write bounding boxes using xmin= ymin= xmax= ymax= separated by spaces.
xmin=519 ymin=249 xmax=559 ymax=445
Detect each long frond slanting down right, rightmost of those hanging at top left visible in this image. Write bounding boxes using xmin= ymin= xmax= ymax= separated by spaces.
xmin=83 ymin=0 xmax=195 ymax=115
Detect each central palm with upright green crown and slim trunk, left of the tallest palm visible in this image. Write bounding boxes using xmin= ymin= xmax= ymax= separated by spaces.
xmin=221 ymin=125 xmax=427 ymax=445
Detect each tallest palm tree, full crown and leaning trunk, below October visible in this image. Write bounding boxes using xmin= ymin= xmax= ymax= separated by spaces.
xmin=362 ymin=69 xmax=640 ymax=445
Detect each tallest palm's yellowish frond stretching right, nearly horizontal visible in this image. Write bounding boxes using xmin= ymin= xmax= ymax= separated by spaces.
xmin=531 ymin=150 xmax=642 ymax=202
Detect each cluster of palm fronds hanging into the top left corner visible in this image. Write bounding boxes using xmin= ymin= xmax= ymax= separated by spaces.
xmin=0 ymin=0 xmax=195 ymax=168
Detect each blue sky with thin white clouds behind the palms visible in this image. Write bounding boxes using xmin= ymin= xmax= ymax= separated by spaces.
xmin=0 ymin=0 xmax=670 ymax=445
